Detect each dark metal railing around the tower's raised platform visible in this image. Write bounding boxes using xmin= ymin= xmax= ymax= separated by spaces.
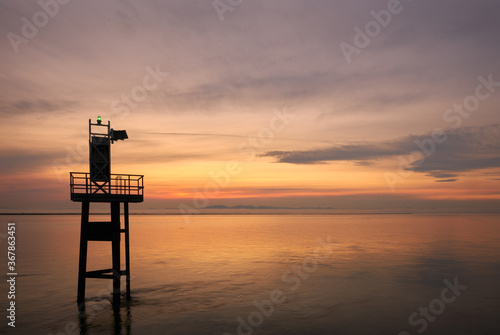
xmin=70 ymin=172 xmax=144 ymax=196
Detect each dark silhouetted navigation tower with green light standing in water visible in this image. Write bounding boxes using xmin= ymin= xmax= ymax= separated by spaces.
xmin=70 ymin=116 xmax=144 ymax=304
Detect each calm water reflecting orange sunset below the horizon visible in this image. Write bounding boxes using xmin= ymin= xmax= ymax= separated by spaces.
xmin=0 ymin=215 xmax=500 ymax=335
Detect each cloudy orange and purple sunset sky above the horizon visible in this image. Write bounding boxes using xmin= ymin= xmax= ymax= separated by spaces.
xmin=0 ymin=0 xmax=500 ymax=212
